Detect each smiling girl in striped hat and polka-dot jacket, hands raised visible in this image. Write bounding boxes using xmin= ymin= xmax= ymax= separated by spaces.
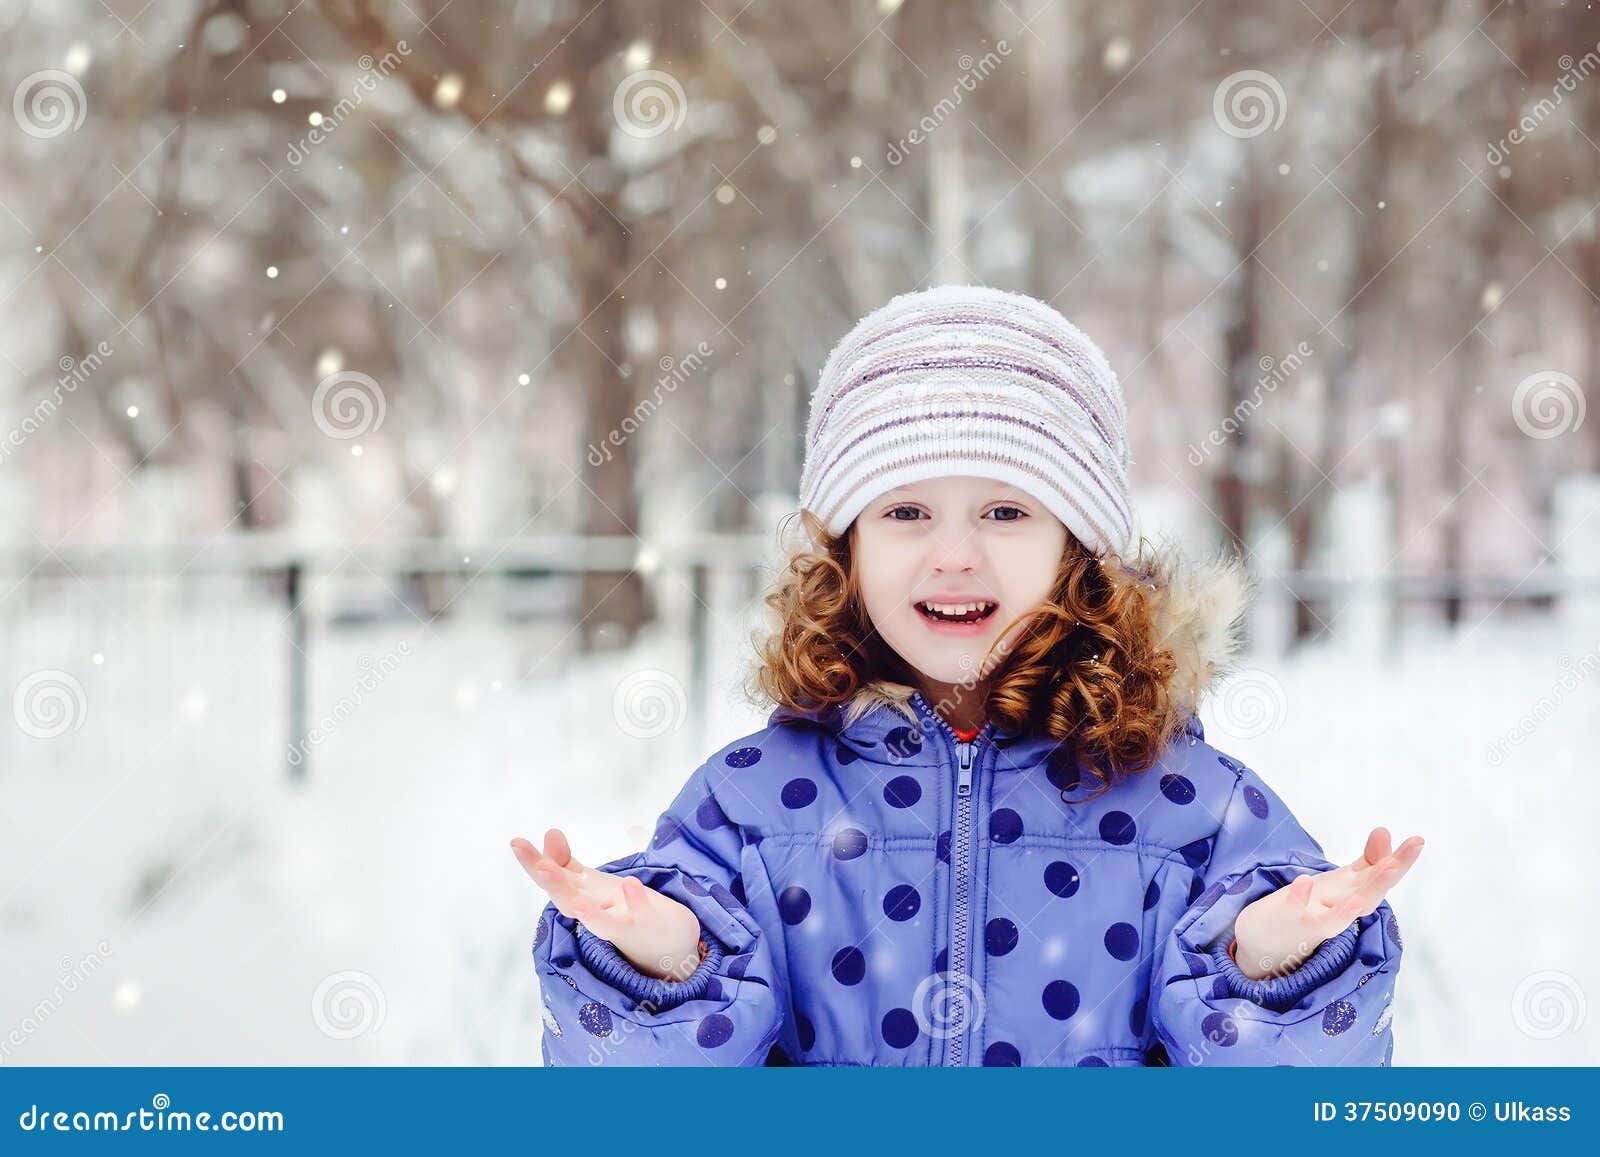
xmin=512 ymin=286 xmax=1422 ymax=1066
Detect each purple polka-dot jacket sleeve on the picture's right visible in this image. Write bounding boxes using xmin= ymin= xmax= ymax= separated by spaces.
xmin=1152 ymin=760 xmax=1400 ymax=1066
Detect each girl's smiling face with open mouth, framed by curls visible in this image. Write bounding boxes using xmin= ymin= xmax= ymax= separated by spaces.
xmin=854 ymin=475 xmax=1069 ymax=701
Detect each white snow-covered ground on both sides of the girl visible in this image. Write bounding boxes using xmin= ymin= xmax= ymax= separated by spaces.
xmin=0 ymin=576 xmax=1600 ymax=1064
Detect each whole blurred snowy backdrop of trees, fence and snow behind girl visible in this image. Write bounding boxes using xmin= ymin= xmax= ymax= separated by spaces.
xmin=0 ymin=0 xmax=1600 ymax=1064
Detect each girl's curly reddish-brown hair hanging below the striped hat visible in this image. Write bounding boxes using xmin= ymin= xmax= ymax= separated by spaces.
xmin=746 ymin=510 xmax=1184 ymax=803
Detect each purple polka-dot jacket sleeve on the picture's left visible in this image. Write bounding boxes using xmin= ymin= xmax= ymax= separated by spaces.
xmin=533 ymin=765 xmax=789 ymax=1066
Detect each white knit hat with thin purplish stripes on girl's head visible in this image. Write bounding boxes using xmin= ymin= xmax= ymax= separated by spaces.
xmin=800 ymin=285 xmax=1133 ymax=557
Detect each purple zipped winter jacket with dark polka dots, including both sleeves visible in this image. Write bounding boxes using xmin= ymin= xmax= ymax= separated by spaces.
xmin=533 ymin=695 xmax=1400 ymax=1067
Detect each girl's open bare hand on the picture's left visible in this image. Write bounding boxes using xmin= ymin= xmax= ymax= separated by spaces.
xmin=510 ymin=827 xmax=699 ymax=981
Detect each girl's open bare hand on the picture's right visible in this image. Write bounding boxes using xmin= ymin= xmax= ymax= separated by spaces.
xmin=1234 ymin=827 xmax=1422 ymax=979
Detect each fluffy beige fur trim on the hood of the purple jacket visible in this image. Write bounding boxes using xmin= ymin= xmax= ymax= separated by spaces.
xmin=832 ymin=547 xmax=1254 ymax=727
